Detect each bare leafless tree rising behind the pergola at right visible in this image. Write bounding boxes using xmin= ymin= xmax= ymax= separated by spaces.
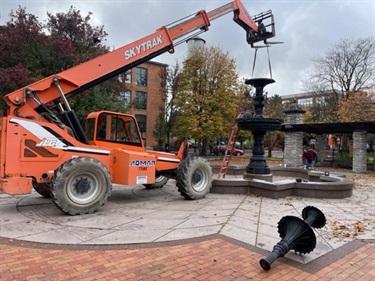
xmin=303 ymin=37 xmax=375 ymax=122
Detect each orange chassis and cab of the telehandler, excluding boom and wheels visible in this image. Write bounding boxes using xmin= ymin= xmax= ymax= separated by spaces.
xmin=0 ymin=112 xmax=182 ymax=194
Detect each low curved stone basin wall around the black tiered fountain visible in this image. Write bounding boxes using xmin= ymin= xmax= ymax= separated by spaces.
xmin=210 ymin=166 xmax=354 ymax=199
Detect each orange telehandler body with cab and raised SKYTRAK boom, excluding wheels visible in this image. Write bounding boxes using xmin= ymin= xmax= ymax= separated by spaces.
xmin=0 ymin=0 xmax=273 ymax=194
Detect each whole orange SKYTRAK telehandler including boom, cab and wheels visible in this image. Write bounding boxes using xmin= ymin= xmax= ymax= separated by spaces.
xmin=0 ymin=0 xmax=275 ymax=215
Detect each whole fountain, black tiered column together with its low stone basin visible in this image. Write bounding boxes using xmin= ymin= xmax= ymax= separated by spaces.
xmin=210 ymin=78 xmax=354 ymax=199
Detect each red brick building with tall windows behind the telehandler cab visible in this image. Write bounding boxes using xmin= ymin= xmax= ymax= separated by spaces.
xmin=119 ymin=61 xmax=168 ymax=147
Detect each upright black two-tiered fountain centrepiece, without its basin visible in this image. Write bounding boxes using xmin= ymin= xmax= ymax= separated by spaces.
xmin=236 ymin=78 xmax=281 ymax=176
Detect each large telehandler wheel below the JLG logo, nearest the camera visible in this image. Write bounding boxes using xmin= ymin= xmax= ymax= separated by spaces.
xmin=52 ymin=157 xmax=112 ymax=215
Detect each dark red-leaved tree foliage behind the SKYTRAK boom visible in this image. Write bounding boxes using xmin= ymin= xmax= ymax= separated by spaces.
xmin=0 ymin=7 xmax=123 ymax=120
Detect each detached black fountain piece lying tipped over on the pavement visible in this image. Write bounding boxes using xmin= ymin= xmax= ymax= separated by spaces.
xmin=259 ymin=206 xmax=326 ymax=271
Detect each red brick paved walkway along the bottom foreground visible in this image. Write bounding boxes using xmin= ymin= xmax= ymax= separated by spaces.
xmin=0 ymin=235 xmax=375 ymax=281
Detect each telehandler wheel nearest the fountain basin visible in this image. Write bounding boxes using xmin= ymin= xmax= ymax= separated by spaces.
xmin=176 ymin=157 xmax=212 ymax=200
